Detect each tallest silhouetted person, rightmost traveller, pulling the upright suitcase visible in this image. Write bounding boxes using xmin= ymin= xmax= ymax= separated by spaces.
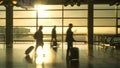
xmin=66 ymin=24 xmax=75 ymax=56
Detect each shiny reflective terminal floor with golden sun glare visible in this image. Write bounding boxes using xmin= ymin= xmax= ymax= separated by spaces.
xmin=0 ymin=42 xmax=120 ymax=68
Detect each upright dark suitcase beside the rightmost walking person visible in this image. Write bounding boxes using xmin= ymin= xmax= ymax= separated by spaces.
xmin=70 ymin=47 xmax=79 ymax=60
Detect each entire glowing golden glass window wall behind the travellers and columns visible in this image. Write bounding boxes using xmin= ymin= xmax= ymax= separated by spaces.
xmin=0 ymin=4 xmax=120 ymax=41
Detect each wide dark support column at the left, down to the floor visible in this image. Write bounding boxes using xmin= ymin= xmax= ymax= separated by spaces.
xmin=5 ymin=0 xmax=13 ymax=48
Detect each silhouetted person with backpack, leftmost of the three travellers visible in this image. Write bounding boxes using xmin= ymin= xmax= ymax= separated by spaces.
xmin=34 ymin=26 xmax=43 ymax=50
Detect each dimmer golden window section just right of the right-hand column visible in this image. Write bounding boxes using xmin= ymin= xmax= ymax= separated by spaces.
xmin=94 ymin=5 xmax=116 ymax=34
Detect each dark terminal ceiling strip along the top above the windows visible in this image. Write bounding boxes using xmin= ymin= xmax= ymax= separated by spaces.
xmin=0 ymin=0 xmax=120 ymax=8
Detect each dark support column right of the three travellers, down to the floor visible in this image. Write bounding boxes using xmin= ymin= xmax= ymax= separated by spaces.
xmin=88 ymin=0 xmax=94 ymax=45
